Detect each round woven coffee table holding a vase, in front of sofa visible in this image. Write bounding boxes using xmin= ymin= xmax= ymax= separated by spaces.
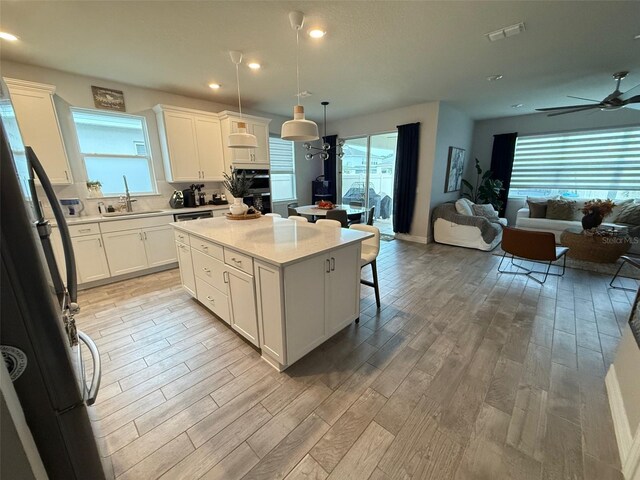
xmin=560 ymin=227 xmax=631 ymax=263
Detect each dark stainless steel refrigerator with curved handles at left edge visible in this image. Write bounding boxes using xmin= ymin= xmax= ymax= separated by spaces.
xmin=0 ymin=79 xmax=113 ymax=480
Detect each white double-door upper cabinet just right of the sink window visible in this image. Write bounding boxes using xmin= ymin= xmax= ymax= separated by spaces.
xmin=153 ymin=105 xmax=225 ymax=182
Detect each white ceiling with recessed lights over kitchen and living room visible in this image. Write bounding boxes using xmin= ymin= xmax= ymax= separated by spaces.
xmin=0 ymin=0 xmax=640 ymax=120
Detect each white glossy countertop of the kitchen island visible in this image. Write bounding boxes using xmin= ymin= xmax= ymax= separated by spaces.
xmin=171 ymin=217 xmax=373 ymax=266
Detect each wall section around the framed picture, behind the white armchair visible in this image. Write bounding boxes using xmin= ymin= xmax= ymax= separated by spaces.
xmin=429 ymin=102 xmax=473 ymax=237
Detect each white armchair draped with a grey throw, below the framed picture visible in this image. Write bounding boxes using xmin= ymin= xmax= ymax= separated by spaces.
xmin=432 ymin=203 xmax=507 ymax=251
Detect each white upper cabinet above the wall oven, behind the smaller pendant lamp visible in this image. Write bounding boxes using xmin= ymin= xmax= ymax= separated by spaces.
xmin=219 ymin=110 xmax=271 ymax=169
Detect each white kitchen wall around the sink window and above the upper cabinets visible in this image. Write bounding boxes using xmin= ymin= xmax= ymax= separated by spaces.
xmin=0 ymin=61 xmax=322 ymax=215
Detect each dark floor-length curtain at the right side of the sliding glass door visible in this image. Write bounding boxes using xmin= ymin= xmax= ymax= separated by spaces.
xmin=393 ymin=122 xmax=420 ymax=233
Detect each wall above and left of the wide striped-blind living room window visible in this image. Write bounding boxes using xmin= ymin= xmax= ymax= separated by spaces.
xmin=465 ymin=109 xmax=640 ymax=224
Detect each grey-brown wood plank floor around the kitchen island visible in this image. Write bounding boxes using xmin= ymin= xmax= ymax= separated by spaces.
xmin=78 ymin=241 xmax=631 ymax=480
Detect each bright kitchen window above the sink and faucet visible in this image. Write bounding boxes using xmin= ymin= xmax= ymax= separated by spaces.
xmin=71 ymin=108 xmax=156 ymax=196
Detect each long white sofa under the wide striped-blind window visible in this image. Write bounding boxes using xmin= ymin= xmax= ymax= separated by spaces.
xmin=516 ymin=198 xmax=640 ymax=255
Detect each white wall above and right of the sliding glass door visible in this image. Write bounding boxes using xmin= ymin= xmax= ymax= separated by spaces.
xmin=331 ymin=102 xmax=446 ymax=242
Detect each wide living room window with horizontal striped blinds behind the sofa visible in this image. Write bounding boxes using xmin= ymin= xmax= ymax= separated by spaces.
xmin=509 ymin=126 xmax=640 ymax=199
